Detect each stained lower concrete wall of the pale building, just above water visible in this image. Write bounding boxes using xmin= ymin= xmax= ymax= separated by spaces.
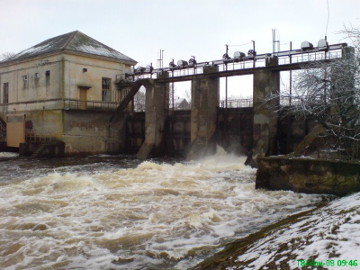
xmin=11 ymin=110 xmax=122 ymax=155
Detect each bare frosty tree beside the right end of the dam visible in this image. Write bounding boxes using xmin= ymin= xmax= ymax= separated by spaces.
xmin=272 ymin=28 xmax=360 ymax=159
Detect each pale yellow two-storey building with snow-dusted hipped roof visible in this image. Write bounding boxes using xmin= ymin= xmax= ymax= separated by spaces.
xmin=0 ymin=31 xmax=137 ymax=154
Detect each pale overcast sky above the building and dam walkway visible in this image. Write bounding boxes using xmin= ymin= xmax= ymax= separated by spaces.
xmin=0 ymin=0 xmax=360 ymax=98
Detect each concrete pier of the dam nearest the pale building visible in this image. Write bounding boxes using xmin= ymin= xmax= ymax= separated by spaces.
xmin=136 ymin=72 xmax=169 ymax=159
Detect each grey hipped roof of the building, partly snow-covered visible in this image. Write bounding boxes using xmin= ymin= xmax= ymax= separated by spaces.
xmin=2 ymin=31 xmax=137 ymax=65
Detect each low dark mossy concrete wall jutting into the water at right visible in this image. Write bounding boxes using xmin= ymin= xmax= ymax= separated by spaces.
xmin=256 ymin=157 xmax=360 ymax=196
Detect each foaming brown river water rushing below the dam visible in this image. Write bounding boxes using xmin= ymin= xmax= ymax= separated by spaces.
xmin=0 ymin=149 xmax=321 ymax=269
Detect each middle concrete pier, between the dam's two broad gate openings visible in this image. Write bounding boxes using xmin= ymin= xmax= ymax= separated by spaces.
xmin=188 ymin=66 xmax=220 ymax=159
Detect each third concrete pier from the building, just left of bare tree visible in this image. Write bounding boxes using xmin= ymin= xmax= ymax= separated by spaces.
xmin=252 ymin=56 xmax=280 ymax=160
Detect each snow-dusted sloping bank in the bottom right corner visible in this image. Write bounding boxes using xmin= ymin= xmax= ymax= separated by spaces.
xmin=227 ymin=193 xmax=360 ymax=270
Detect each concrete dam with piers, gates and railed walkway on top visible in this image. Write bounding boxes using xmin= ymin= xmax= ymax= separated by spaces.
xmin=109 ymin=44 xmax=350 ymax=160
